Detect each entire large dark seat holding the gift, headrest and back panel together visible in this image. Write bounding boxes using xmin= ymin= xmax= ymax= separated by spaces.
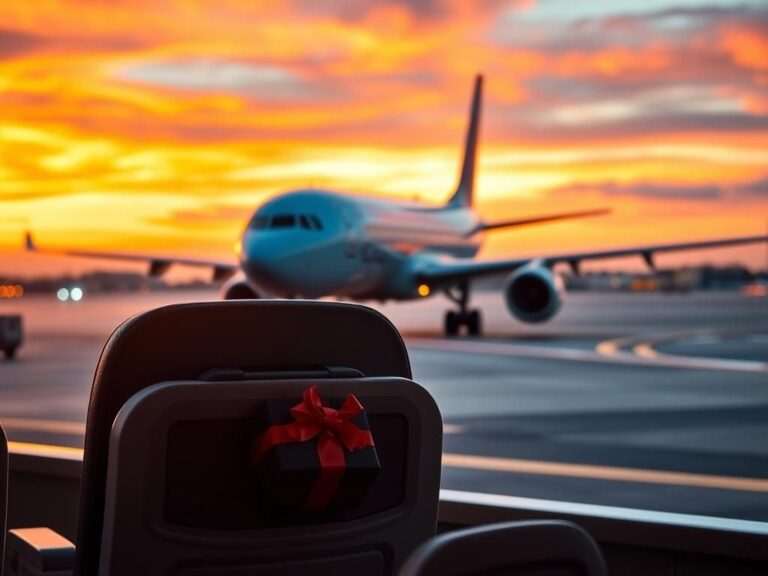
xmin=74 ymin=301 xmax=442 ymax=576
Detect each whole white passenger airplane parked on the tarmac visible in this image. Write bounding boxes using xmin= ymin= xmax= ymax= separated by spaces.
xmin=26 ymin=75 xmax=768 ymax=336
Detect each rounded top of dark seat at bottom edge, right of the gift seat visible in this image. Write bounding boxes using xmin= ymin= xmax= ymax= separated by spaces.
xmin=399 ymin=520 xmax=607 ymax=576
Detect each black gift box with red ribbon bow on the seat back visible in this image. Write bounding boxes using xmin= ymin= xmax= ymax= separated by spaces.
xmin=251 ymin=386 xmax=381 ymax=511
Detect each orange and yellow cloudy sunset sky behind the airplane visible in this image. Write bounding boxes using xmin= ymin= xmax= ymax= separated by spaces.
xmin=0 ymin=0 xmax=768 ymax=275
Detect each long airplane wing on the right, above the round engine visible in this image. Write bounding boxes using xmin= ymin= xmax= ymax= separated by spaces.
xmin=417 ymin=236 xmax=768 ymax=284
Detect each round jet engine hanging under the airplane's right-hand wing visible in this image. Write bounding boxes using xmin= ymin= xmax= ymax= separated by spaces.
xmin=504 ymin=264 xmax=565 ymax=323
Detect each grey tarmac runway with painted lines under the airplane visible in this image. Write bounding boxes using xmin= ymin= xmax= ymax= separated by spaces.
xmin=0 ymin=292 xmax=768 ymax=521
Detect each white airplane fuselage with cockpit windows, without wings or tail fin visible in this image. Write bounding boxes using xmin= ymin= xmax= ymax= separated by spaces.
xmin=240 ymin=190 xmax=482 ymax=300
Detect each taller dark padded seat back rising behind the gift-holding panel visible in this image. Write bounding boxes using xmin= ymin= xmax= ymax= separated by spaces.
xmin=75 ymin=301 xmax=428 ymax=576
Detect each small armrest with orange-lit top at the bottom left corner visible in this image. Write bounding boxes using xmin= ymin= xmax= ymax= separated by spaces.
xmin=6 ymin=528 xmax=75 ymax=576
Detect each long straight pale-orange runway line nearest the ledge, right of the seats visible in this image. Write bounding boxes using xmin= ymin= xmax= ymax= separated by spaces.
xmin=443 ymin=454 xmax=768 ymax=493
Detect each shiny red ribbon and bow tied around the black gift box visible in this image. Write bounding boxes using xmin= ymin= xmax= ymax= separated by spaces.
xmin=251 ymin=386 xmax=373 ymax=510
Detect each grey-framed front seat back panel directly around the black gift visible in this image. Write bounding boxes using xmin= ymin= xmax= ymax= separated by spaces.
xmin=99 ymin=378 xmax=442 ymax=576
